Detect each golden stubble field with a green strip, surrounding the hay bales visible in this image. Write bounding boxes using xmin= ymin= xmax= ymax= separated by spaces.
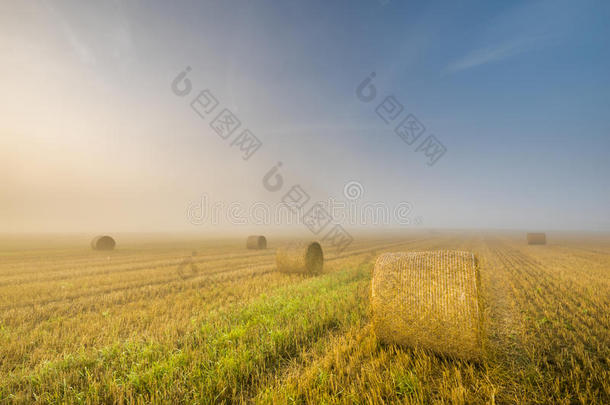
xmin=0 ymin=231 xmax=610 ymax=404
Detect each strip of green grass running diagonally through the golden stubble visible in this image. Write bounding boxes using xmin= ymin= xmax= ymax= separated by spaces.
xmin=0 ymin=264 xmax=370 ymax=403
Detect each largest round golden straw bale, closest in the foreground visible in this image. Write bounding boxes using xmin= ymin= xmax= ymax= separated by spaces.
xmin=371 ymin=251 xmax=481 ymax=359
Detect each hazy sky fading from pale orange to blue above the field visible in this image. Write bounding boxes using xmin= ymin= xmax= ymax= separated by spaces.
xmin=0 ymin=0 xmax=610 ymax=233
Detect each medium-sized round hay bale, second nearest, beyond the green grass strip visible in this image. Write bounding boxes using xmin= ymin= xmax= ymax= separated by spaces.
xmin=275 ymin=242 xmax=324 ymax=274
